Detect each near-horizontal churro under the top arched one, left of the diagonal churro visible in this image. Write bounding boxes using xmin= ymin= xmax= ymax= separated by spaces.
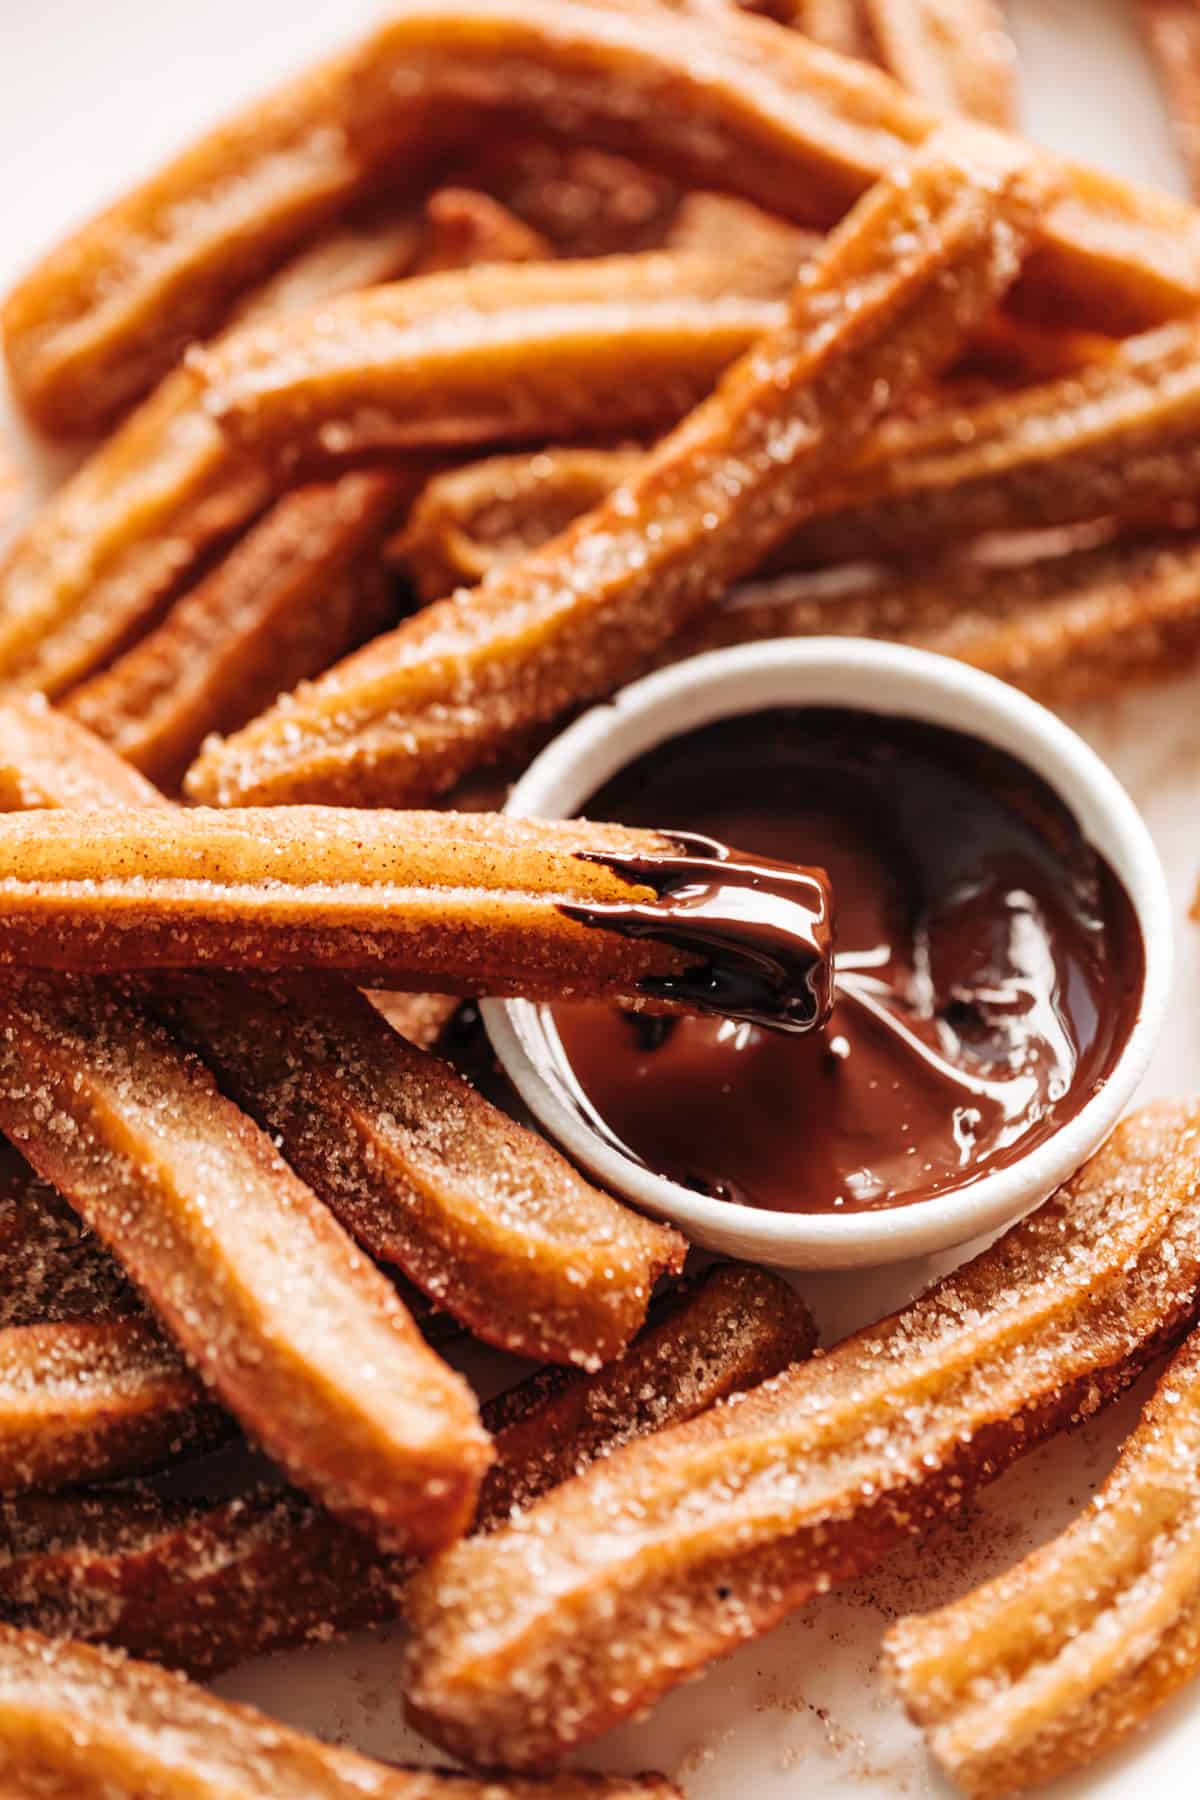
xmin=189 ymin=253 xmax=797 ymax=472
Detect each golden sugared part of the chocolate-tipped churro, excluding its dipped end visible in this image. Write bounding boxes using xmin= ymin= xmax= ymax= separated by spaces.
xmin=0 ymin=806 xmax=827 ymax=1012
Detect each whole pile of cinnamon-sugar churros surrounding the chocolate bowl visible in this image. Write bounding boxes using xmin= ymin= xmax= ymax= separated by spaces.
xmin=0 ymin=0 xmax=1200 ymax=1800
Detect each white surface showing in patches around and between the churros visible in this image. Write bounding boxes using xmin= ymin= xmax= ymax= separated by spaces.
xmin=0 ymin=0 xmax=1200 ymax=1800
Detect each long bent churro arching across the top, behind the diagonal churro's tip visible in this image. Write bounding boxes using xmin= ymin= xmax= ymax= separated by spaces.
xmin=4 ymin=0 xmax=1200 ymax=432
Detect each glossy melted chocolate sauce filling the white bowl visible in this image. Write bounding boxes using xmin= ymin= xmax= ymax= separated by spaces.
xmin=554 ymin=707 xmax=1144 ymax=1211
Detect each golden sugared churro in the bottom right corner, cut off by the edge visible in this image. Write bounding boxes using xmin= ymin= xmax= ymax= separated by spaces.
xmin=885 ymin=1334 xmax=1200 ymax=1800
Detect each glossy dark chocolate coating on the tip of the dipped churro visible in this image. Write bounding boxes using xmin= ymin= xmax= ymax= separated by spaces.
xmin=561 ymin=832 xmax=833 ymax=1031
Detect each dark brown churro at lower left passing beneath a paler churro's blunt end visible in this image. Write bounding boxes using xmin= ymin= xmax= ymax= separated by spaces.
xmin=0 ymin=1264 xmax=813 ymax=1674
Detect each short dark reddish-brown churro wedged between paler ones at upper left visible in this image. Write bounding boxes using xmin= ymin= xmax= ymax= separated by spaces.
xmin=65 ymin=472 xmax=406 ymax=787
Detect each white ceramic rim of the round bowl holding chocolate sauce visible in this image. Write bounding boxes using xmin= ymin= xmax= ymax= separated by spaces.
xmin=480 ymin=637 xmax=1173 ymax=1269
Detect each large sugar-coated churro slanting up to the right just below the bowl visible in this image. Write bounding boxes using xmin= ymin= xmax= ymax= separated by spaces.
xmin=408 ymin=1105 xmax=1200 ymax=1768
